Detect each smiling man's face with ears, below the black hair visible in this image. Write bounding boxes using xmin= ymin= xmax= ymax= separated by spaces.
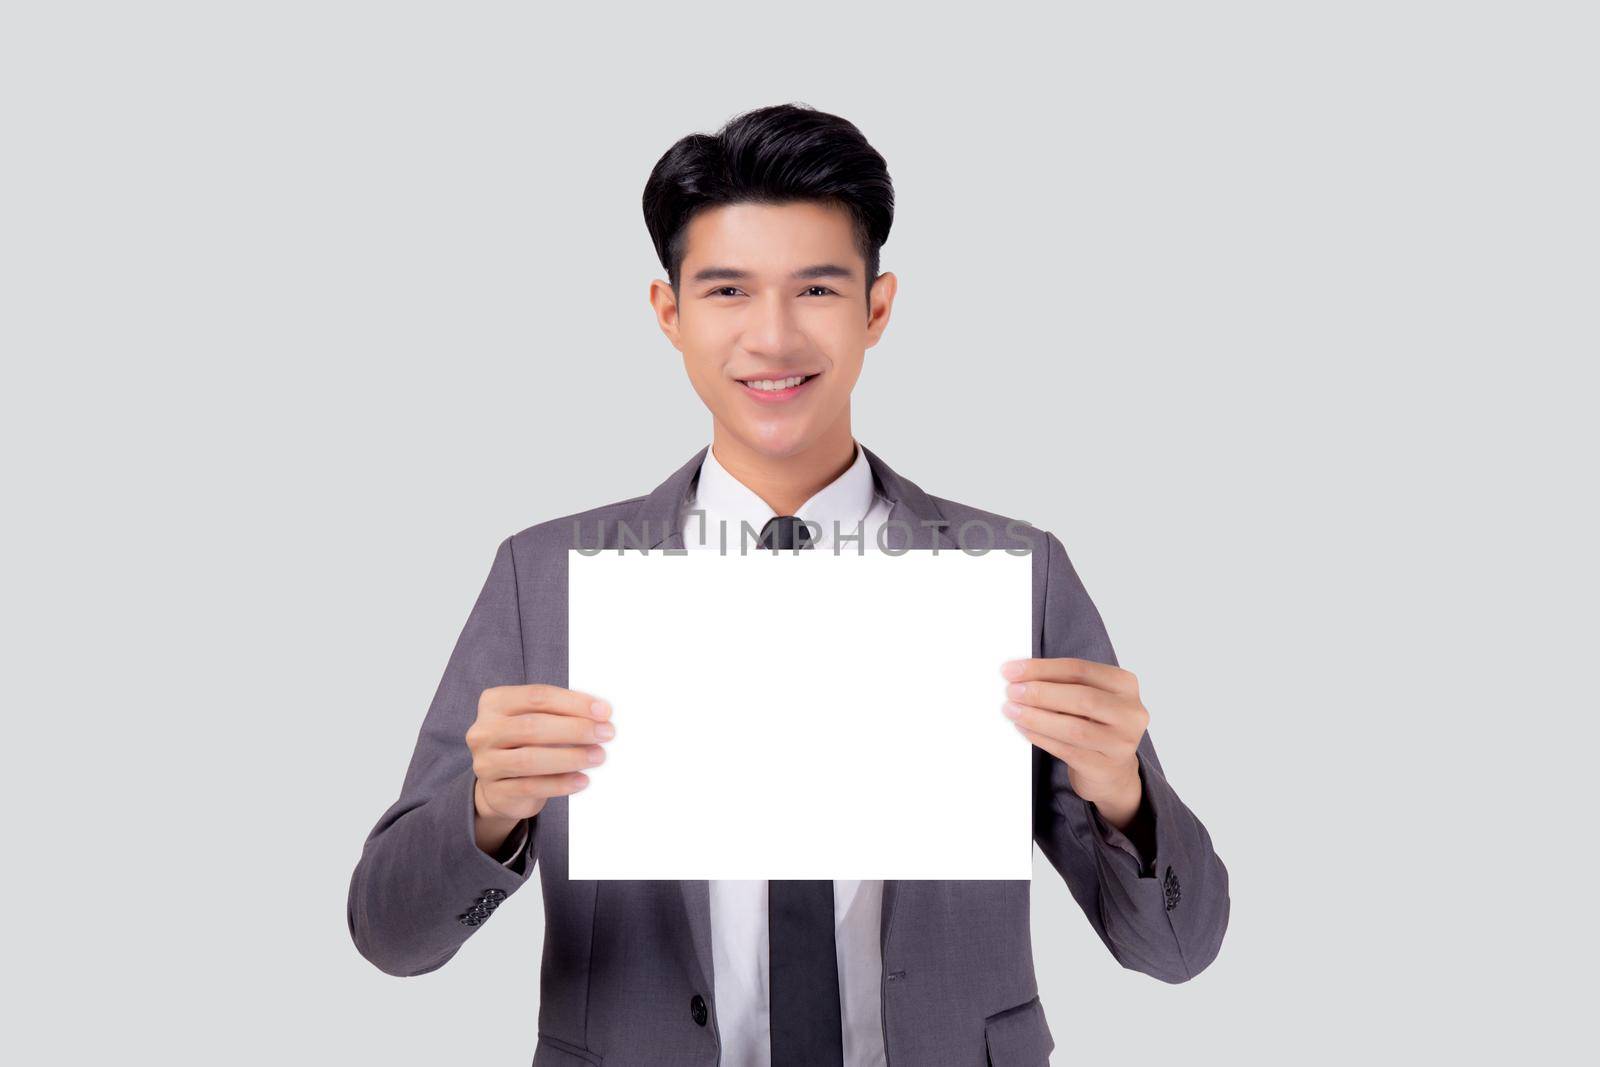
xmin=650 ymin=203 xmax=894 ymax=459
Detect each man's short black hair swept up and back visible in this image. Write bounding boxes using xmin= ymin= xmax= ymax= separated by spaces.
xmin=645 ymin=104 xmax=894 ymax=308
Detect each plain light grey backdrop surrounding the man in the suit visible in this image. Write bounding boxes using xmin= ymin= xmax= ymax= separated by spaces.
xmin=0 ymin=0 xmax=1600 ymax=1064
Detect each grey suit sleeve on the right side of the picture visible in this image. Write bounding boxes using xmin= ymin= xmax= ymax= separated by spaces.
xmin=1034 ymin=533 xmax=1229 ymax=982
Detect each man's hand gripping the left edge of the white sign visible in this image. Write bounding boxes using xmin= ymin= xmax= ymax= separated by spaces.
xmin=467 ymin=685 xmax=616 ymax=853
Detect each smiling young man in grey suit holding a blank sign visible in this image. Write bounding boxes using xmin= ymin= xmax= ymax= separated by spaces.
xmin=349 ymin=106 xmax=1229 ymax=1067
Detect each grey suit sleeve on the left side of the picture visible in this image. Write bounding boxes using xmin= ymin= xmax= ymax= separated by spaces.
xmin=347 ymin=539 xmax=539 ymax=976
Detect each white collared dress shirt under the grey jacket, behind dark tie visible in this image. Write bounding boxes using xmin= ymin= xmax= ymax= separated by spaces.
xmin=683 ymin=443 xmax=890 ymax=1067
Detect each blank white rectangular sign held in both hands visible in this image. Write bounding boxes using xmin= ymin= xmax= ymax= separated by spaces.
xmin=568 ymin=549 xmax=1032 ymax=880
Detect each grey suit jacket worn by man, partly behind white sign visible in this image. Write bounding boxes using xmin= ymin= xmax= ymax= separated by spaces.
xmin=347 ymin=448 xmax=1229 ymax=1067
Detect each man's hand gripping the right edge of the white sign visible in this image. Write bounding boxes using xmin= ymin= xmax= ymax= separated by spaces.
xmin=1000 ymin=659 xmax=1150 ymax=830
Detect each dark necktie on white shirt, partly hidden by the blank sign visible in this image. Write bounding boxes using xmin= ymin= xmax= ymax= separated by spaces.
xmin=760 ymin=515 xmax=845 ymax=1067
